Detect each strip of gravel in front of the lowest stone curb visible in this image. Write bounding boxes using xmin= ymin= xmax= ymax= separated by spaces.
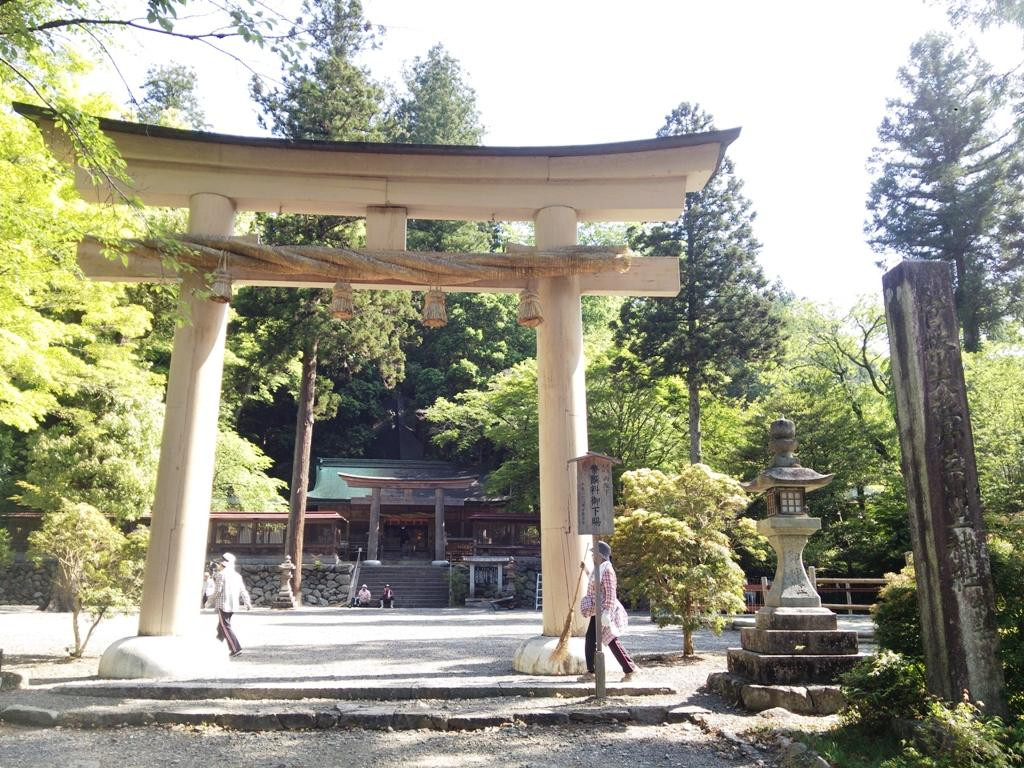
xmin=0 ymin=725 xmax=771 ymax=768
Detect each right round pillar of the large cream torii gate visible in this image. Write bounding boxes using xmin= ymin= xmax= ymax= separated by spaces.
xmin=513 ymin=206 xmax=587 ymax=675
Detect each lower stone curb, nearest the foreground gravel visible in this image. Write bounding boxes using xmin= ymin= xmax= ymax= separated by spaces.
xmin=0 ymin=705 xmax=710 ymax=731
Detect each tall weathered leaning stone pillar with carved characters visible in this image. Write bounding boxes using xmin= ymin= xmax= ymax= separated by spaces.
xmin=882 ymin=261 xmax=1008 ymax=717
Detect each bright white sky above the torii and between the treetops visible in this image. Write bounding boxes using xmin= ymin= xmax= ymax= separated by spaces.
xmin=97 ymin=0 xmax=1024 ymax=307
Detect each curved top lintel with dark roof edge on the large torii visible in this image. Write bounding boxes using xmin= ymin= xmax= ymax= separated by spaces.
xmin=14 ymin=103 xmax=739 ymax=221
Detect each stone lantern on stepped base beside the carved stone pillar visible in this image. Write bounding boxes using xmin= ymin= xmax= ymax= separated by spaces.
xmin=708 ymin=419 xmax=863 ymax=715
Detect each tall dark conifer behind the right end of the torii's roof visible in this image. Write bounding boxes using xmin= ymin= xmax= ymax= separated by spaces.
xmin=617 ymin=102 xmax=780 ymax=464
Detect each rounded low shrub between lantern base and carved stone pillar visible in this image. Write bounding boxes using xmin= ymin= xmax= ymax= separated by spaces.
xmin=840 ymin=650 xmax=931 ymax=730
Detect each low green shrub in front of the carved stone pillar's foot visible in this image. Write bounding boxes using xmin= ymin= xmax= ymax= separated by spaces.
xmin=880 ymin=701 xmax=1024 ymax=768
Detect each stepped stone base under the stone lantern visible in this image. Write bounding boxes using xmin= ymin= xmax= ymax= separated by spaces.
xmin=708 ymin=607 xmax=867 ymax=715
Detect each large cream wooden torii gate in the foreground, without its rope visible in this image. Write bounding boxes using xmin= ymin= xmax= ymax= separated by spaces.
xmin=14 ymin=104 xmax=739 ymax=677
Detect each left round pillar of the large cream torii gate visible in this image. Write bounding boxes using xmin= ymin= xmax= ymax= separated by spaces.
xmin=99 ymin=194 xmax=234 ymax=678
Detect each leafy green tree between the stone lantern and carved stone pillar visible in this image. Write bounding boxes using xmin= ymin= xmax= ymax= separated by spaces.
xmin=738 ymin=302 xmax=910 ymax=577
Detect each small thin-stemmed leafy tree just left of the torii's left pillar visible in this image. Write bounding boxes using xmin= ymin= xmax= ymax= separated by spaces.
xmin=29 ymin=501 xmax=148 ymax=658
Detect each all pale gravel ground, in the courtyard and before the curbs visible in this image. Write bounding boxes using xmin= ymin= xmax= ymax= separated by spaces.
xmin=0 ymin=606 xmax=858 ymax=768
